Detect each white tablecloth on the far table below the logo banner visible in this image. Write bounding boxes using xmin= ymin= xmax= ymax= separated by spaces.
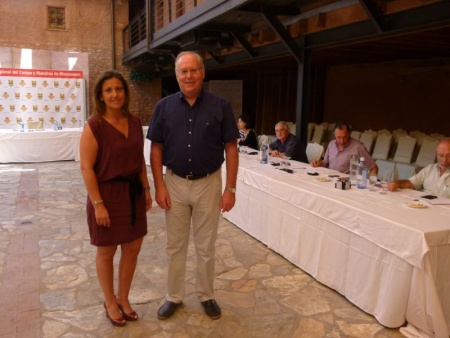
xmin=0 ymin=128 xmax=82 ymax=163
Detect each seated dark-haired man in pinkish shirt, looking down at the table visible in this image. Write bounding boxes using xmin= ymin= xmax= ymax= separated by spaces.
xmin=311 ymin=121 xmax=378 ymax=176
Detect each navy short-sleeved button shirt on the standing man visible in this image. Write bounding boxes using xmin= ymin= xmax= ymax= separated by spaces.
xmin=147 ymin=91 xmax=239 ymax=176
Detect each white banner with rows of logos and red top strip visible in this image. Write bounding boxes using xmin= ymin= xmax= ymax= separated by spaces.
xmin=0 ymin=68 xmax=86 ymax=129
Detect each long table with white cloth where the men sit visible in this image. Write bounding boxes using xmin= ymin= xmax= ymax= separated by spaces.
xmin=224 ymin=155 xmax=450 ymax=338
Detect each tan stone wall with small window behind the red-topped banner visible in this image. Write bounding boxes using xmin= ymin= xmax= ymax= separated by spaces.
xmin=0 ymin=0 xmax=161 ymax=124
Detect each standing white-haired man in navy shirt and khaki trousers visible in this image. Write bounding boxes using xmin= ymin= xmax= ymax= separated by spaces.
xmin=147 ymin=52 xmax=239 ymax=319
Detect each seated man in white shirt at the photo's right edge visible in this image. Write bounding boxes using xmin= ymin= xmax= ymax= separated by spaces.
xmin=388 ymin=138 xmax=450 ymax=197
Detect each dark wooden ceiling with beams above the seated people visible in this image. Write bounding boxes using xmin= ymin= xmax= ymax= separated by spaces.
xmin=124 ymin=0 xmax=450 ymax=76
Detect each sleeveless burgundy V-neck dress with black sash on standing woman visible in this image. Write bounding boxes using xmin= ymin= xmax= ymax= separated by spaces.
xmin=86 ymin=116 xmax=147 ymax=246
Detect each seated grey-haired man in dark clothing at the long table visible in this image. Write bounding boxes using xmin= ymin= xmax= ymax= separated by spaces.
xmin=269 ymin=121 xmax=308 ymax=163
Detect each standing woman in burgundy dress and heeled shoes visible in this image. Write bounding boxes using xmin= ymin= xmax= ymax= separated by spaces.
xmin=80 ymin=70 xmax=152 ymax=326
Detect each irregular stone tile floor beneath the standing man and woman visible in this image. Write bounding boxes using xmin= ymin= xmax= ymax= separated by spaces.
xmin=0 ymin=161 xmax=403 ymax=338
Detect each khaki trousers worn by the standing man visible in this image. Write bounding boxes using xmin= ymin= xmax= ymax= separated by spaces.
xmin=165 ymin=169 xmax=222 ymax=303
